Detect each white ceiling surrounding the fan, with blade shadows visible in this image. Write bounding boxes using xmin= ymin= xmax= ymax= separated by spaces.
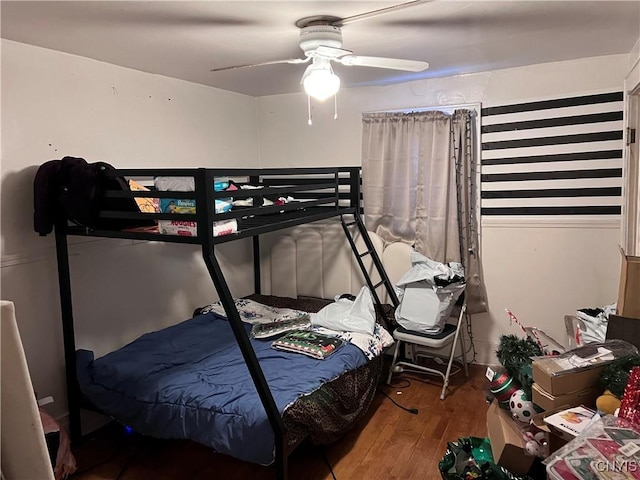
xmin=0 ymin=0 xmax=640 ymax=96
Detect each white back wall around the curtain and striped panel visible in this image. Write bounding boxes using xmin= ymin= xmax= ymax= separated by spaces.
xmin=258 ymin=55 xmax=629 ymax=363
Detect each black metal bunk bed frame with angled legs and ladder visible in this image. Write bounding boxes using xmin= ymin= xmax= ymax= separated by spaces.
xmin=55 ymin=167 xmax=398 ymax=479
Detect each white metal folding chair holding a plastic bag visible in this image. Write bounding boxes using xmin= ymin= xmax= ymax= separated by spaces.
xmin=387 ymin=293 xmax=469 ymax=400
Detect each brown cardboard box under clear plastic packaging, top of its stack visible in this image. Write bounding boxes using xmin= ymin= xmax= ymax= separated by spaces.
xmin=531 ymin=357 xmax=606 ymax=396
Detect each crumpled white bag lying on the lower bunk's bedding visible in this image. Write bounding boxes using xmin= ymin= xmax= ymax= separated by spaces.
xmin=311 ymin=287 xmax=376 ymax=335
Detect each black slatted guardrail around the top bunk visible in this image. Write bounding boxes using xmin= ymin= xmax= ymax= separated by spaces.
xmin=67 ymin=167 xmax=361 ymax=244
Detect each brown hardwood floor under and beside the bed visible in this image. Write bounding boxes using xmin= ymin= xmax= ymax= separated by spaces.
xmin=70 ymin=365 xmax=488 ymax=480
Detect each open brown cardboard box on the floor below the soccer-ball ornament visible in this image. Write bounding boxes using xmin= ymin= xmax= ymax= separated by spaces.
xmin=487 ymin=401 xmax=535 ymax=475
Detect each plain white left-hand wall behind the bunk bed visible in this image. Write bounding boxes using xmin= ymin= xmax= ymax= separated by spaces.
xmin=0 ymin=40 xmax=258 ymax=415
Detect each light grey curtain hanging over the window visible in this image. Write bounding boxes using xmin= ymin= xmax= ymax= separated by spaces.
xmin=362 ymin=110 xmax=487 ymax=313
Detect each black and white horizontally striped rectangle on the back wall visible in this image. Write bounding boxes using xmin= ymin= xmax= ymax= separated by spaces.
xmin=481 ymin=92 xmax=624 ymax=218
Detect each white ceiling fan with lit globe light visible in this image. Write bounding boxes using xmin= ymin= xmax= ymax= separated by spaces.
xmin=211 ymin=0 xmax=431 ymax=101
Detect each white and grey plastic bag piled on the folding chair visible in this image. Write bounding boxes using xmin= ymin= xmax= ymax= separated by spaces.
xmin=395 ymin=252 xmax=465 ymax=335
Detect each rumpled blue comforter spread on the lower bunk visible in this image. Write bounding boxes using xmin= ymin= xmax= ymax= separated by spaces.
xmin=77 ymin=313 xmax=366 ymax=465
